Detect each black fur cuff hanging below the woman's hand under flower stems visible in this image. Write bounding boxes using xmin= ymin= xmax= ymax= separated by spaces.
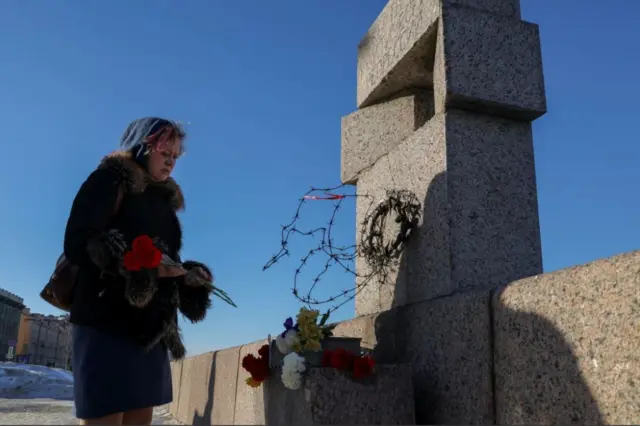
xmin=178 ymin=260 xmax=213 ymax=323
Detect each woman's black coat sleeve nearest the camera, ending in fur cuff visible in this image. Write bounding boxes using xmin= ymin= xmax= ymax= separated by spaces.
xmin=64 ymin=169 xmax=126 ymax=270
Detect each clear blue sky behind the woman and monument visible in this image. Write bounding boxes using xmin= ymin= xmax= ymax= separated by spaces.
xmin=0 ymin=0 xmax=640 ymax=354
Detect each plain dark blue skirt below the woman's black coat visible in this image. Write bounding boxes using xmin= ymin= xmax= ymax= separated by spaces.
xmin=72 ymin=324 xmax=173 ymax=419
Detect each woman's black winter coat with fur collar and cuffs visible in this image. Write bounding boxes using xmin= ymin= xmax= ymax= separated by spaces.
xmin=64 ymin=152 xmax=213 ymax=359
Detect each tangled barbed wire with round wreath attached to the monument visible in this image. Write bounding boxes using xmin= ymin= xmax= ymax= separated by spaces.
xmin=263 ymin=184 xmax=422 ymax=313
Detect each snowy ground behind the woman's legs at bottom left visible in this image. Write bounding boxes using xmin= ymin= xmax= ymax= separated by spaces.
xmin=0 ymin=362 xmax=180 ymax=425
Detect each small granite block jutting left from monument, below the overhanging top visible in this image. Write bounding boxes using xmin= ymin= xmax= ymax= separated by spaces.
xmin=341 ymin=91 xmax=433 ymax=184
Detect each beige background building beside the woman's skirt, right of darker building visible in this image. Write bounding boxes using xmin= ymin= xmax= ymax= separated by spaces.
xmin=16 ymin=309 xmax=71 ymax=368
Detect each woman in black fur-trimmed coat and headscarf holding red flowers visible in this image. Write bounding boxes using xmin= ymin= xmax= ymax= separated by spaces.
xmin=64 ymin=117 xmax=212 ymax=425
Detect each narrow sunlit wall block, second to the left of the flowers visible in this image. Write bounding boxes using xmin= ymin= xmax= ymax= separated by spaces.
xmin=211 ymin=346 xmax=244 ymax=425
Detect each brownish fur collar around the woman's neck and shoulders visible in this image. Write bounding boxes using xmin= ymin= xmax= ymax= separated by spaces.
xmin=98 ymin=151 xmax=184 ymax=211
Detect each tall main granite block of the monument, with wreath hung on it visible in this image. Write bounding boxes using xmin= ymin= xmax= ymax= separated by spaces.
xmin=356 ymin=110 xmax=542 ymax=316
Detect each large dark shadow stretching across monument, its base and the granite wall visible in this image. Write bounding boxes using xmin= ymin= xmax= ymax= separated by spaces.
xmin=374 ymin=173 xmax=603 ymax=424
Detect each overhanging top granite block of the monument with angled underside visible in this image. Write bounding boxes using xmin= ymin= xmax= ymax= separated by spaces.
xmin=357 ymin=0 xmax=546 ymax=121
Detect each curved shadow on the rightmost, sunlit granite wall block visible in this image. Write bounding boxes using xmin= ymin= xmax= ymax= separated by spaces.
xmin=492 ymin=290 xmax=604 ymax=425
